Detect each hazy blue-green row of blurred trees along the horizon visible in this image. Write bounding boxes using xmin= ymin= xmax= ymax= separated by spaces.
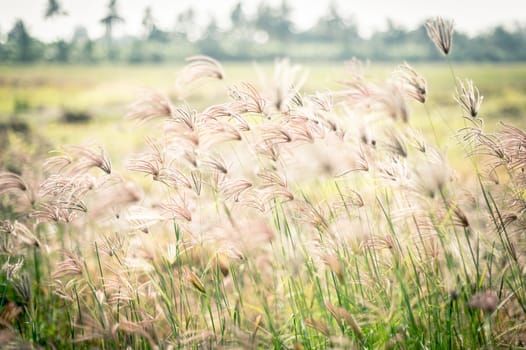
xmin=0 ymin=0 xmax=526 ymax=64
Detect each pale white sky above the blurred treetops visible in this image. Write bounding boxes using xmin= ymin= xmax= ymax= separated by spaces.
xmin=0 ymin=0 xmax=526 ymax=41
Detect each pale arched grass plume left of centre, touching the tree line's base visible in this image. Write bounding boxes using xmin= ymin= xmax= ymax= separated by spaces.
xmin=177 ymin=55 xmax=225 ymax=87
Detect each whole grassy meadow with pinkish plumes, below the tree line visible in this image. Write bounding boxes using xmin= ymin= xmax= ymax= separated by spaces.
xmin=0 ymin=57 xmax=526 ymax=349
